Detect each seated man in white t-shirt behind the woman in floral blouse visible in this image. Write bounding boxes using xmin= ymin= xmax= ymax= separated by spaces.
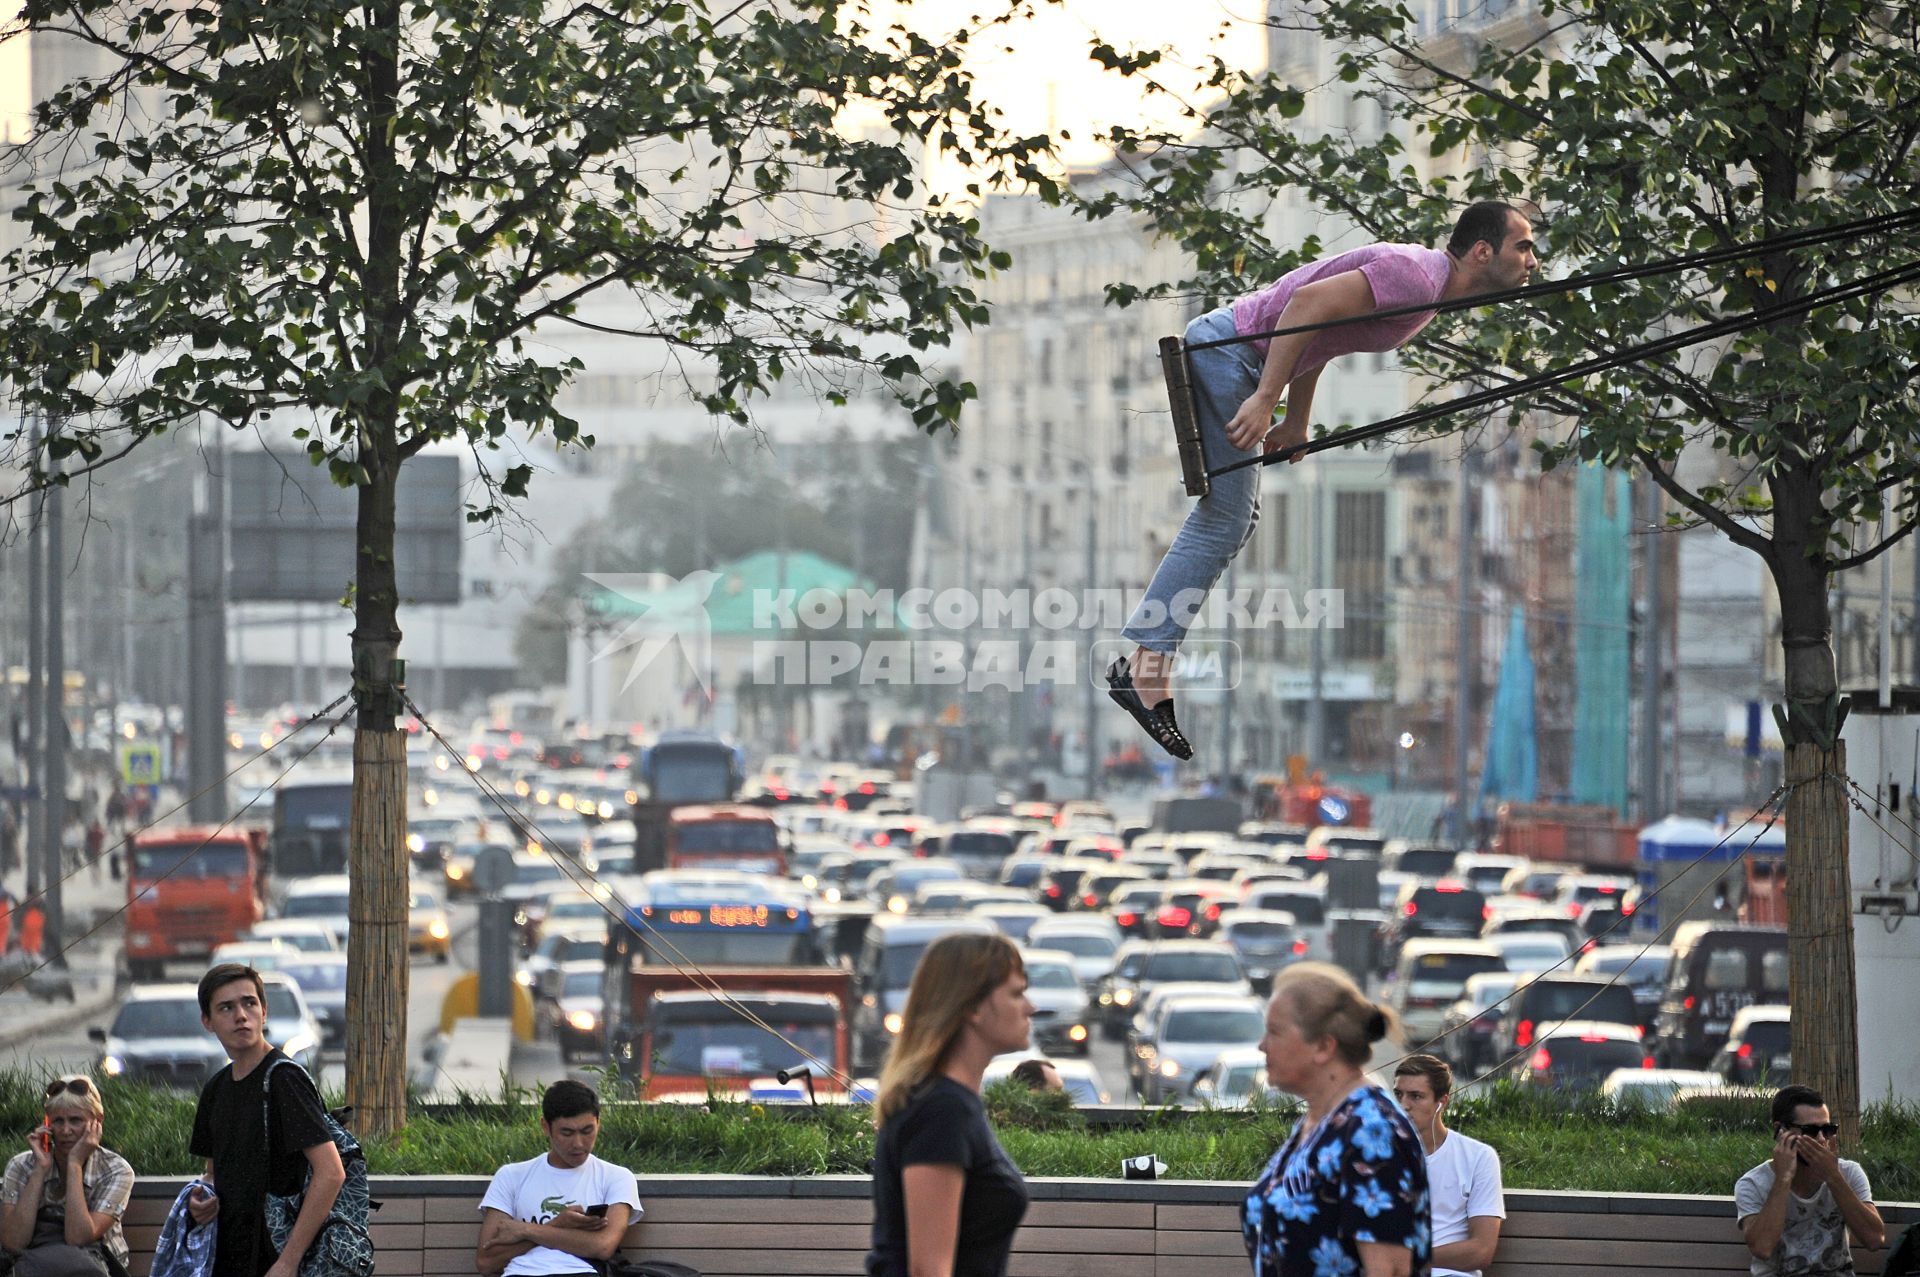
xmin=1394 ymin=1056 xmax=1507 ymax=1277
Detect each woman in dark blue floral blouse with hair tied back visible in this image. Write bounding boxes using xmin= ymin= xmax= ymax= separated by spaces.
xmin=1240 ymin=962 xmax=1432 ymax=1277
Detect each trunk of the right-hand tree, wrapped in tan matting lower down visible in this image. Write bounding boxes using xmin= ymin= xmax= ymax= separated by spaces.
xmin=1772 ymin=522 xmax=1860 ymax=1146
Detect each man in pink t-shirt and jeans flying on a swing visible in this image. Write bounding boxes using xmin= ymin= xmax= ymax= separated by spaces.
xmin=1106 ymin=202 xmax=1536 ymax=759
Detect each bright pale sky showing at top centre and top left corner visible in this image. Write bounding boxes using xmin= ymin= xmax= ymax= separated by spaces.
xmin=0 ymin=0 xmax=1261 ymax=175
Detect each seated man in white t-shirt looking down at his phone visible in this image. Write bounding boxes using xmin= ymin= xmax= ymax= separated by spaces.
xmin=474 ymin=1081 xmax=639 ymax=1277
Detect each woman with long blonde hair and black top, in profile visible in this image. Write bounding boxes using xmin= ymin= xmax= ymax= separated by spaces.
xmin=866 ymin=933 xmax=1033 ymax=1277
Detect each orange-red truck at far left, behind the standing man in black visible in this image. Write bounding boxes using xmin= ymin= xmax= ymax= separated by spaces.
xmin=127 ymin=826 xmax=267 ymax=979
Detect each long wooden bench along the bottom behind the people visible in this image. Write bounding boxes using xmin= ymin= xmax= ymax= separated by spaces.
xmin=127 ymin=1175 xmax=1920 ymax=1277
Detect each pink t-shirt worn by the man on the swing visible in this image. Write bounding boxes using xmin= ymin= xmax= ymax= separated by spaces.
xmin=1233 ymin=244 xmax=1452 ymax=376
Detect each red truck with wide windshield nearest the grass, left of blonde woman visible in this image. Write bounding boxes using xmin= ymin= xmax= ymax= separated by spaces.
xmin=614 ymin=966 xmax=852 ymax=1100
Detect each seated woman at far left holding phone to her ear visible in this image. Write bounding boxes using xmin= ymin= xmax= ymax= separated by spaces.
xmin=0 ymin=1075 xmax=132 ymax=1277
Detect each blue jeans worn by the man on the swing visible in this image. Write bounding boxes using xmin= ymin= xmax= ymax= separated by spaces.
xmin=1121 ymin=307 xmax=1265 ymax=653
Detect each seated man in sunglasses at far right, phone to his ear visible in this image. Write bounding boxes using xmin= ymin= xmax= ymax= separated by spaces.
xmin=1734 ymin=1087 xmax=1887 ymax=1277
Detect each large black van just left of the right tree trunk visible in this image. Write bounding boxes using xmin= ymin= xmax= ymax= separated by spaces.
xmin=1653 ymin=922 xmax=1788 ymax=1068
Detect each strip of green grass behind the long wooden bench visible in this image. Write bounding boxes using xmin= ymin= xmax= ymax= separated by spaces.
xmin=0 ymin=1070 xmax=1920 ymax=1202
